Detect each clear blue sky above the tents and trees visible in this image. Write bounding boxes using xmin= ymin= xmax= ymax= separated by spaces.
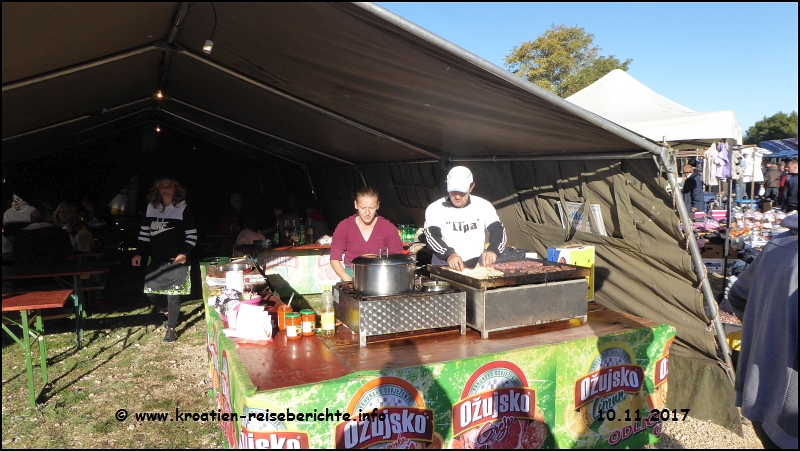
xmin=378 ymin=2 xmax=798 ymax=133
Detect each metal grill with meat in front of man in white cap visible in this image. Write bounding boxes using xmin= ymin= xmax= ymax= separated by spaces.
xmin=428 ymin=260 xmax=591 ymax=339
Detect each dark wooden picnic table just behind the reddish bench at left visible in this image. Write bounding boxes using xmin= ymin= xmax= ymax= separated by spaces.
xmin=3 ymin=262 xmax=106 ymax=349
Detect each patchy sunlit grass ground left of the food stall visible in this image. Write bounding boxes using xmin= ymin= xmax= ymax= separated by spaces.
xmin=2 ymin=266 xmax=223 ymax=448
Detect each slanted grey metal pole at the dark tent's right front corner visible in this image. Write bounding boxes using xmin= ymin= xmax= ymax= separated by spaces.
xmin=660 ymin=148 xmax=735 ymax=383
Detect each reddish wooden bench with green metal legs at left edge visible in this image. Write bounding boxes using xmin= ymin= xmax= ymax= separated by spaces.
xmin=3 ymin=290 xmax=72 ymax=407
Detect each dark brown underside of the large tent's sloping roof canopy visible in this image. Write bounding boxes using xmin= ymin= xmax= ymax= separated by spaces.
xmin=2 ymin=3 xmax=664 ymax=164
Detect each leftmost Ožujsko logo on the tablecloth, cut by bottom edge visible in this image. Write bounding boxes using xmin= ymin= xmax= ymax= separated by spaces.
xmin=239 ymin=400 xmax=310 ymax=449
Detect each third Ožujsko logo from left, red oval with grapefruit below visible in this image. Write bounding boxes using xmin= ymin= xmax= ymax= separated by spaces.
xmin=451 ymin=361 xmax=547 ymax=449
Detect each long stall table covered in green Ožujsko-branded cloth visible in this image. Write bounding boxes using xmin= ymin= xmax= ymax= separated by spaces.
xmin=206 ymin=292 xmax=675 ymax=448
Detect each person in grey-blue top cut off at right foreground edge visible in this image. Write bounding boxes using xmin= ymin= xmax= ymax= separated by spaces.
xmin=728 ymin=210 xmax=798 ymax=449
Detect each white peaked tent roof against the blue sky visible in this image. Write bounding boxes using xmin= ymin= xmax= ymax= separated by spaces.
xmin=567 ymin=69 xmax=742 ymax=148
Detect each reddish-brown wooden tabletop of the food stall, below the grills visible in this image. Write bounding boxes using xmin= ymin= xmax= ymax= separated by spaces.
xmin=237 ymin=310 xmax=659 ymax=391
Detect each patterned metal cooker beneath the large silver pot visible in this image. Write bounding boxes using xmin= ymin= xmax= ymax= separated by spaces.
xmin=333 ymin=282 xmax=467 ymax=347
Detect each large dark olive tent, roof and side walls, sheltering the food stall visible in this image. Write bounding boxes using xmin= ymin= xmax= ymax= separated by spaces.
xmin=2 ymin=2 xmax=740 ymax=430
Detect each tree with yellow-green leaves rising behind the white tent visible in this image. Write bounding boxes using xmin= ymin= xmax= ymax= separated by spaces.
xmin=505 ymin=25 xmax=633 ymax=97
